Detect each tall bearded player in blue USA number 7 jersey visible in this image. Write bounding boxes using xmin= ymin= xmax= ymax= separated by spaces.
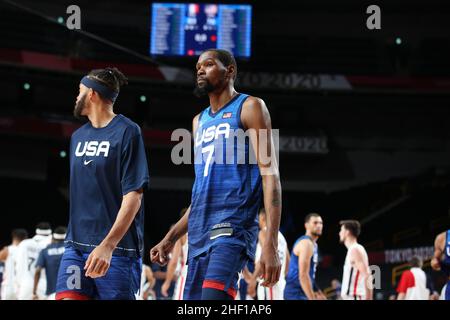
xmin=150 ymin=49 xmax=281 ymax=300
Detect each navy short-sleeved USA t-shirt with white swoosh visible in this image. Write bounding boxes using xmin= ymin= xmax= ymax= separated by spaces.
xmin=66 ymin=114 xmax=149 ymax=257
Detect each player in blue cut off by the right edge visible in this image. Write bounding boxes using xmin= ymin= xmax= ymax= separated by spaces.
xmin=431 ymin=230 xmax=450 ymax=300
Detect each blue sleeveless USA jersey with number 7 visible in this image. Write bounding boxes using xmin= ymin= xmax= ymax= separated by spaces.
xmin=188 ymin=94 xmax=262 ymax=260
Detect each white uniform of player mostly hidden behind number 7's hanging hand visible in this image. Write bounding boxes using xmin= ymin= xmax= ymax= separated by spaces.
xmin=255 ymin=231 xmax=289 ymax=300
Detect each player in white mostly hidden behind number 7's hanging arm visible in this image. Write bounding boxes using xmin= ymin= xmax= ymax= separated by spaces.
xmin=248 ymin=208 xmax=290 ymax=300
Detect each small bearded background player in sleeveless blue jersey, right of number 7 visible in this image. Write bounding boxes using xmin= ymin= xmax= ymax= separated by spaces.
xmin=284 ymin=213 xmax=323 ymax=300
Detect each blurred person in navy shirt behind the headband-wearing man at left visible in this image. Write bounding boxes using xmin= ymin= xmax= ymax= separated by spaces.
xmin=33 ymin=226 xmax=66 ymax=300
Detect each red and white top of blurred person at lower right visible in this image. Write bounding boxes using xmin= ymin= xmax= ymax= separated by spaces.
xmin=397 ymin=268 xmax=430 ymax=300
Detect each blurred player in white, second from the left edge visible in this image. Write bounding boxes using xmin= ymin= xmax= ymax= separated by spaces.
xmin=14 ymin=222 xmax=52 ymax=300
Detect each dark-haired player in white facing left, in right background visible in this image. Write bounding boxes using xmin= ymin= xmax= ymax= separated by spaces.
xmin=339 ymin=220 xmax=373 ymax=300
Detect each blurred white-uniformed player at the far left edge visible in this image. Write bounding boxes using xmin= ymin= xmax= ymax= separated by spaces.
xmin=0 ymin=229 xmax=28 ymax=300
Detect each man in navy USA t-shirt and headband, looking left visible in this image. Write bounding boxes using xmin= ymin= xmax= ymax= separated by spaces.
xmin=56 ymin=68 xmax=149 ymax=300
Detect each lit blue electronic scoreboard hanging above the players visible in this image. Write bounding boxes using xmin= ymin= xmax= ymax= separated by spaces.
xmin=150 ymin=3 xmax=252 ymax=58
